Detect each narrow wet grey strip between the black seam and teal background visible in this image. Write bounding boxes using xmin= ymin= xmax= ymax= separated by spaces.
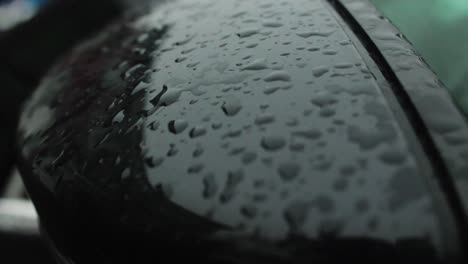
xmin=342 ymin=0 xmax=468 ymax=245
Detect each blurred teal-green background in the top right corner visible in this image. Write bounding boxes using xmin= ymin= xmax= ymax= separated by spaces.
xmin=371 ymin=0 xmax=468 ymax=114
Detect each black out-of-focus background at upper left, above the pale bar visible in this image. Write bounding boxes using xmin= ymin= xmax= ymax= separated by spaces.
xmin=0 ymin=0 xmax=122 ymax=191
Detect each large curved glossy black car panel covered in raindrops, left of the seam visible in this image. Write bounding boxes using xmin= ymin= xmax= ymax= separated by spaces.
xmin=14 ymin=0 xmax=468 ymax=263
